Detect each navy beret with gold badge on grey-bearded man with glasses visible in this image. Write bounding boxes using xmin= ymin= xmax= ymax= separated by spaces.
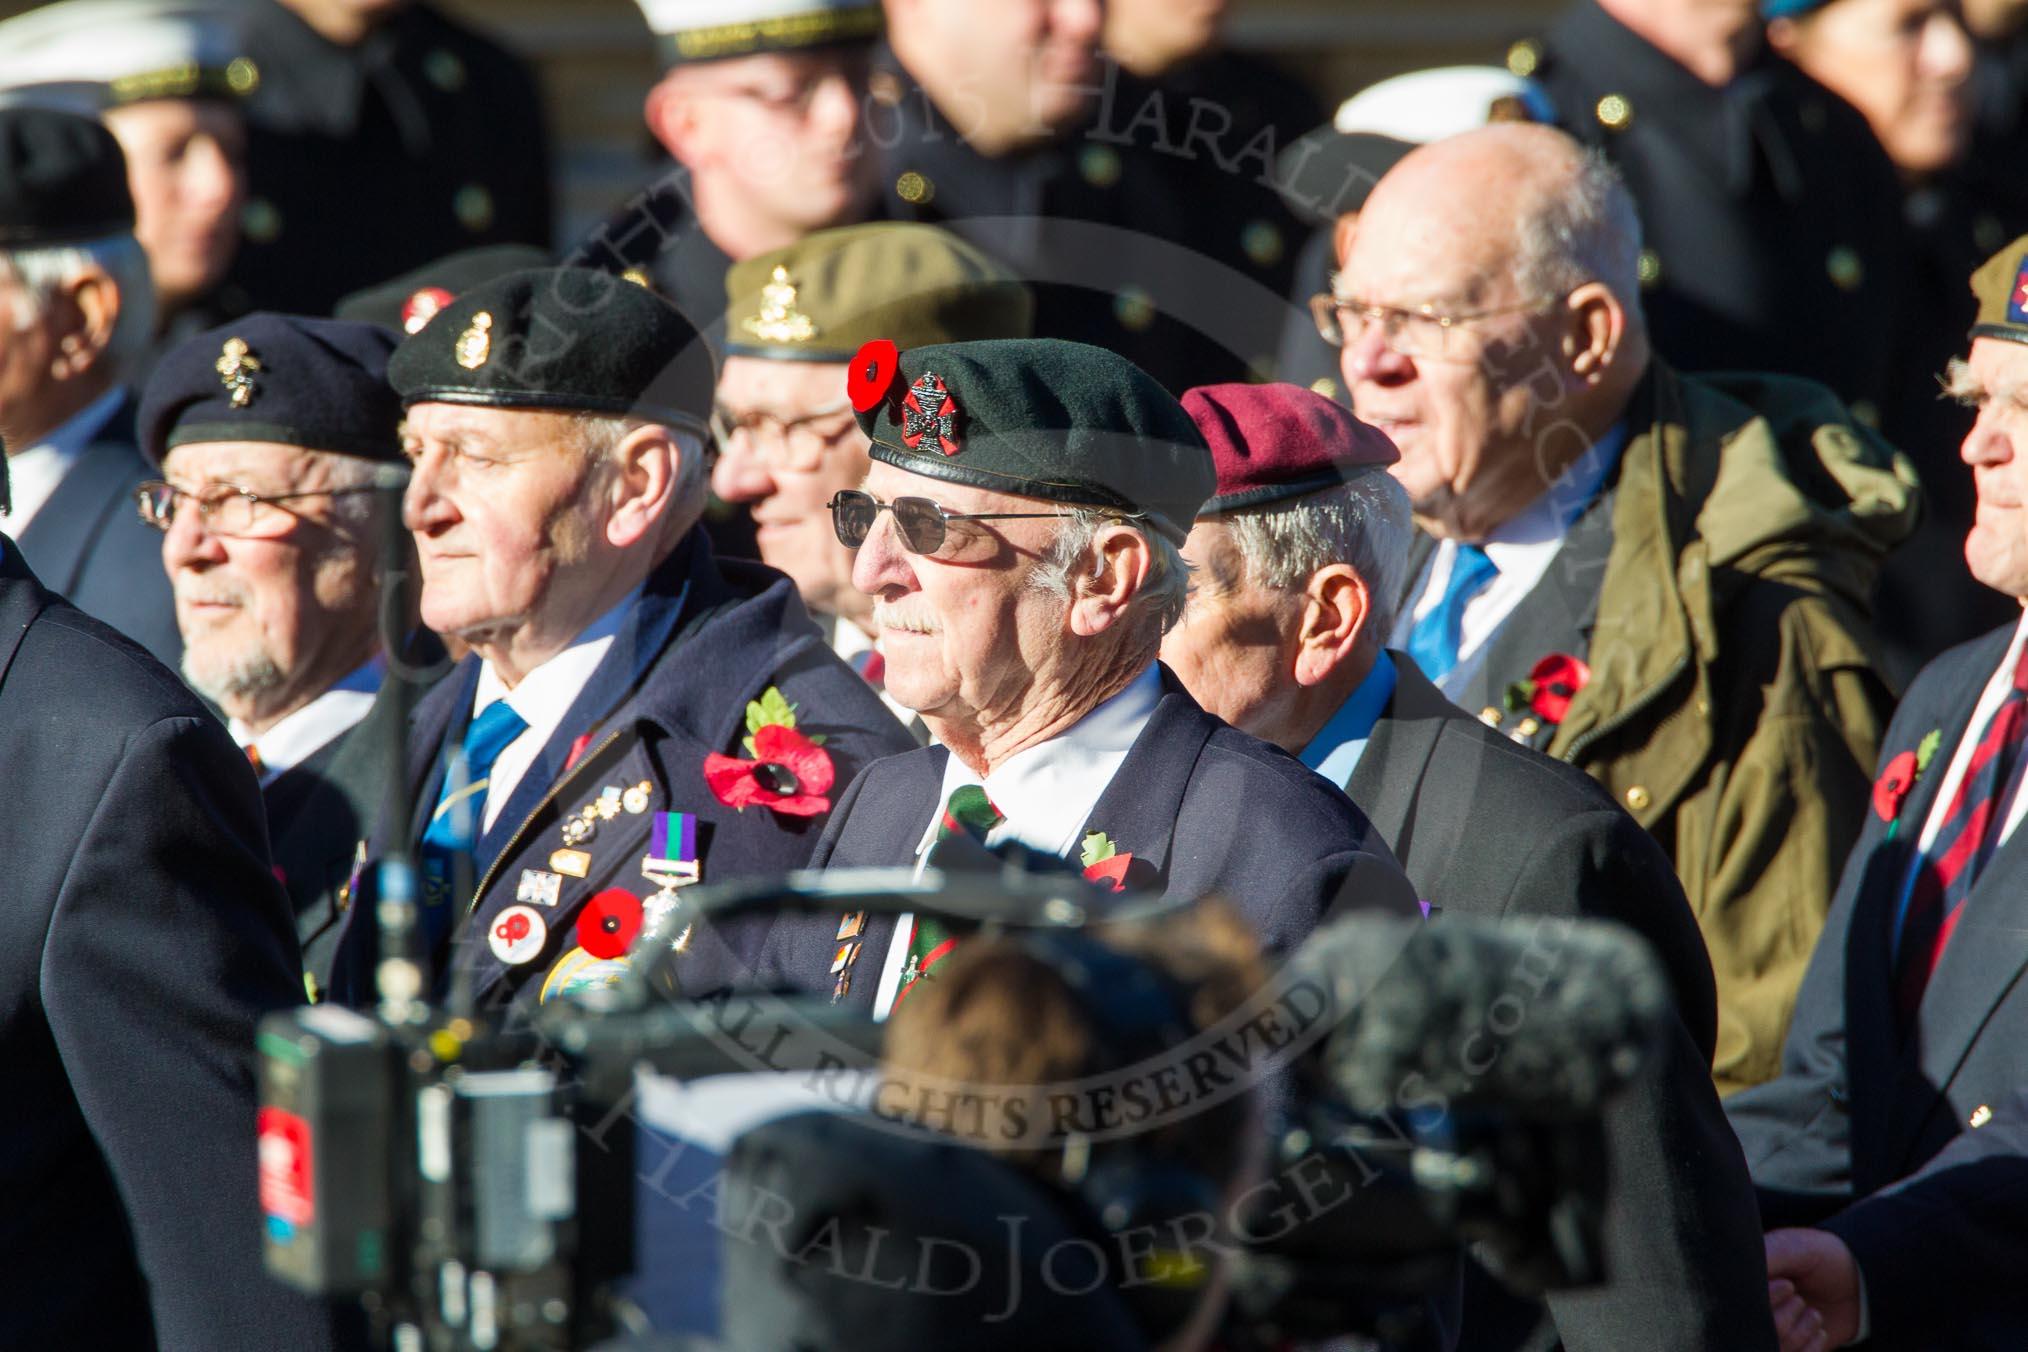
xmin=138 ymin=314 xmax=402 ymax=466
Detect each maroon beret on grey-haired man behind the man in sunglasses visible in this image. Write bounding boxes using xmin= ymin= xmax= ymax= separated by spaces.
xmin=1182 ymin=385 xmax=1401 ymax=517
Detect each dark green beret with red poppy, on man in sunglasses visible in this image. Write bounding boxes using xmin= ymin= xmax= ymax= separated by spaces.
xmin=846 ymin=339 xmax=1219 ymax=543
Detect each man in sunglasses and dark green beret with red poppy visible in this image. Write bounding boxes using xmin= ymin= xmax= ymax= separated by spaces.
xmin=769 ymin=339 xmax=1418 ymax=1013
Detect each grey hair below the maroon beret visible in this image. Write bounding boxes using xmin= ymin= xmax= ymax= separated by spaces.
xmin=1223 ymin=468 xmax=1414 ymax=645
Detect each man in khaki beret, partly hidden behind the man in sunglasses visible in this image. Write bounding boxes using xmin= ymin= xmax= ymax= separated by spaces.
xmin=712 ymin=223 xmax=1034 ymax=709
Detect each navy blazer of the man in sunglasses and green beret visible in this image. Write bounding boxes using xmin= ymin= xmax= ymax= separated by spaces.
xmin=763 ymin=667 xmax=1422 ymax=1009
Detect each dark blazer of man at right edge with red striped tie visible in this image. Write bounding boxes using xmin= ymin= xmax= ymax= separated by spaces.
xmin=1726 ymin=626 xmax=2028 ymax=1348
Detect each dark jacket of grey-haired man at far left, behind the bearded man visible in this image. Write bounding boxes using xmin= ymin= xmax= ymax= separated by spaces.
xmin=20 ymin=397 xmax=183 ymax=671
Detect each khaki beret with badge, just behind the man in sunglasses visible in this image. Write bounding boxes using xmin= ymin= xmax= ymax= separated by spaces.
xmin=726 ymin=221 xmax=1034 ymax=361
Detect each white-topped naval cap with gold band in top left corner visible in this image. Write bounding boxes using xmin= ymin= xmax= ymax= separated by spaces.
xmin=0 ymin=0 xmax=260 ymax=116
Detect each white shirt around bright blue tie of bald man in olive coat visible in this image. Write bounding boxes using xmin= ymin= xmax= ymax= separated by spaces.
xmin=1389 ymin=424 xmax=1626 ymax=699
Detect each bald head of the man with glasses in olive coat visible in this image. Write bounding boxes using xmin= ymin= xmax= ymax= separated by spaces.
xmin=1332 ymin=124 xmax=1649 ymax=539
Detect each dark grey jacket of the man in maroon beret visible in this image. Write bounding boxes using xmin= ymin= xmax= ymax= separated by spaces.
xmin=1347 ymin=653 xmax=1775 ymax=1352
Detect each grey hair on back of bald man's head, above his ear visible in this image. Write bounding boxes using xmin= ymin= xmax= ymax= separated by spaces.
xmin=1515 ymin=150 xmax=1641 ymax=310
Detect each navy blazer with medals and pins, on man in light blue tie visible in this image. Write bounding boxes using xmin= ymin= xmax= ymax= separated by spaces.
xmin=333 ymin=529 xmax=915 ymax=1005
